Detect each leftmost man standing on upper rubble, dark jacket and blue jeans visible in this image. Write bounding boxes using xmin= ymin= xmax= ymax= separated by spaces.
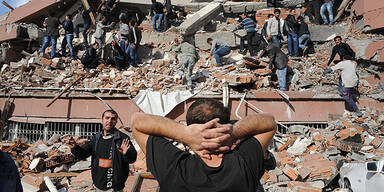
xmin=40 ymin=12 xmax=60 ymax=59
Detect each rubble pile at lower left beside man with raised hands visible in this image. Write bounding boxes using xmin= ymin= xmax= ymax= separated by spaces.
xmin=1 ymin=135 xmax=92 ymax=191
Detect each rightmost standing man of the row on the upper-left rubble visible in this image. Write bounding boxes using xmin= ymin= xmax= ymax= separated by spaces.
xmin=126 ymin=19 xmax=141 ymax=67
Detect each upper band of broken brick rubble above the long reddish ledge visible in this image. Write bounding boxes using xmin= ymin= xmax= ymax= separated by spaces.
xmin=0 ymin=11 xmax=384 ymax=100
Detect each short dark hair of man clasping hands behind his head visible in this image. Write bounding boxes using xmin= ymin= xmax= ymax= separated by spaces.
xmin=187 ymin=99 xmax=230 ymax=125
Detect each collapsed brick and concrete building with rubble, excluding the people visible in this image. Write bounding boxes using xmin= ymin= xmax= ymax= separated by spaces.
xmin=0 ymin=0 xmax=384 ymax=191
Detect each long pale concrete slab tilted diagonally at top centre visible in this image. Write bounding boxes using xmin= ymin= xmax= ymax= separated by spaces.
xmin=178 ymin=2 xmax=222 ymax=36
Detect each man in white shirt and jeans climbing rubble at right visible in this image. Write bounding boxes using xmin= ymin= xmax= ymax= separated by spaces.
xmin=323 ymin=55 xmax=363 ymax=117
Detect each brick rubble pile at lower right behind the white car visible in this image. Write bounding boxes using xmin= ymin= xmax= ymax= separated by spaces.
xmin=261 ymin=109 xmax=384 ymax=192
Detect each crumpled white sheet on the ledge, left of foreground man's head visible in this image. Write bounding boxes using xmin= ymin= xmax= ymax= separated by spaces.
xmin=132 ymin=90 xmax=197 ymax=117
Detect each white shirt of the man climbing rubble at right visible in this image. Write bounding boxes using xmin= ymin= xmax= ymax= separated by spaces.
xmin=331 ymin=60 xmax=359 ymax=87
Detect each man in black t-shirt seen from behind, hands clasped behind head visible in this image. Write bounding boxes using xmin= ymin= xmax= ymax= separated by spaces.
xmin=131 ymin=99 xmax=276 ymax=192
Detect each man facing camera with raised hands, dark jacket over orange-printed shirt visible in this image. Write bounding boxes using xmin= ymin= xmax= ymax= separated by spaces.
xmin=69 ymin=110 xmax=137 ymax=192
